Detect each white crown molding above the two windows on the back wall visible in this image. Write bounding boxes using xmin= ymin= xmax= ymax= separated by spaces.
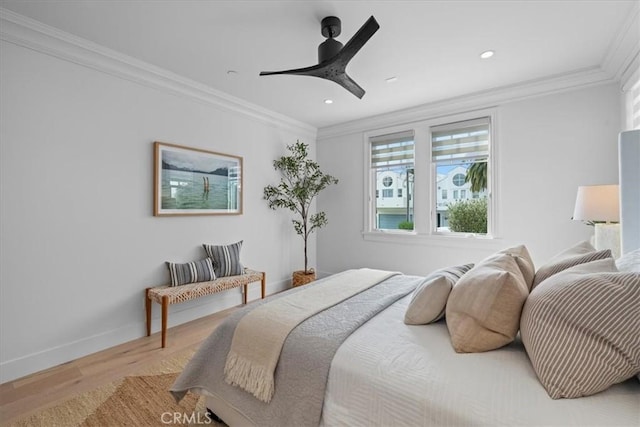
xmin=317 ymin=67 xmax=615 ymax=142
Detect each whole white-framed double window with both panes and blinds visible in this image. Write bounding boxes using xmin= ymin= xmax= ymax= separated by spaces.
xmin=365 ymin=110 xmax=497 ymax=239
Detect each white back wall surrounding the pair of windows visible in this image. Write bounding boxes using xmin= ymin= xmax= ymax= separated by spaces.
xmin=317 ymin=84 xmax=621 ymax=274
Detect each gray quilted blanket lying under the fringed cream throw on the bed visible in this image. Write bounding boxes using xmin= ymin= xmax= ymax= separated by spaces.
xmin=171 ymin=275 xmax=424 ymax=427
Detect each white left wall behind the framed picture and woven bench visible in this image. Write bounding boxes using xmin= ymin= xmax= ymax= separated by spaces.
xmin=0 ymin=41 xmax=315 ymax=382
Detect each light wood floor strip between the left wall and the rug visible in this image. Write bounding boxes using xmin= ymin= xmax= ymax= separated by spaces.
xmin=0 ymin=307 xmax=237 ymax=424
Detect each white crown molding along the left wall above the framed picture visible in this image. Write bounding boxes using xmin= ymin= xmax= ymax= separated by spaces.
xmin=0 ymin=7 xmax=317 ymax=138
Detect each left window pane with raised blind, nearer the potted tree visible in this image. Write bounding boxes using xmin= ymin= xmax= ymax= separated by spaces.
xmin=369 ymin=131 xmax=414 ymax=230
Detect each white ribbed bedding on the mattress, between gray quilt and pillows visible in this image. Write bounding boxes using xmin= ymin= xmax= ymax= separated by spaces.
xmin=322 ymin=296 xmax=640 ymax=427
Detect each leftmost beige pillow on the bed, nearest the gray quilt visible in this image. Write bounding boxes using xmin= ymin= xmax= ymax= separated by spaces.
xmin=404 ymin=264 xmax=473 ymax=325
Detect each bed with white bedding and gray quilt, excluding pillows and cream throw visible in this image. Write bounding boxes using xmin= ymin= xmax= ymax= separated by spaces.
xmin=172 ymin=256 xmax=640 ymax=426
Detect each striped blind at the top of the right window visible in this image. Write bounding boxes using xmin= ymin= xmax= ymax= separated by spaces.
xmin=431 ymin=117 xmax=490 ymax=162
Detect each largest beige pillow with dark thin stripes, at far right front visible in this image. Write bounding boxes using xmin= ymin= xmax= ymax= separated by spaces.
xmin=520 ymin=260 xmax=640 ymax=399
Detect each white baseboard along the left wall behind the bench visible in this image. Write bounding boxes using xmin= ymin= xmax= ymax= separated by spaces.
xmin=0 ymin=280 xmax=289 ymax=384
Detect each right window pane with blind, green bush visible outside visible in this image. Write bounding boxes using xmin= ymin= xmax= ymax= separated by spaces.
xmin=431 ymin=117 xmax=491 ymax=234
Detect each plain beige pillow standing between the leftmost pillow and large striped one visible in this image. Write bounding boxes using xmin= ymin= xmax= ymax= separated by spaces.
xmin=446 ymin=253 xmax=529 ymax=353
